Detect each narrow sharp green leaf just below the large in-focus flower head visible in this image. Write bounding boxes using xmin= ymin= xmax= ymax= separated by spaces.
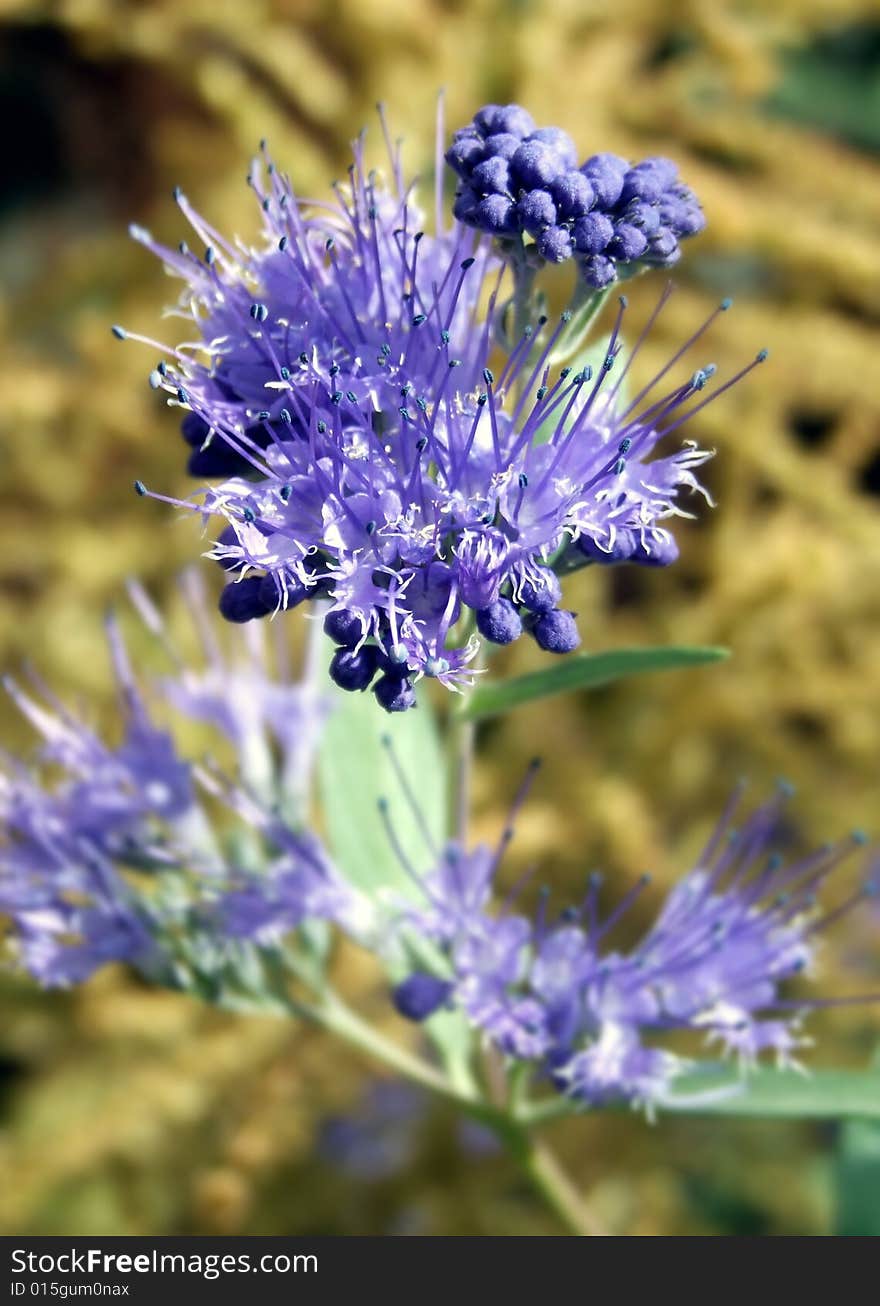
xmin=461 ymin=646 xmax=730 ymax=721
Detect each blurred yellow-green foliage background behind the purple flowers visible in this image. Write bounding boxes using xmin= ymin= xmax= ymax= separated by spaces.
xmin=0 ymin=0 xmax=880 ymax=1234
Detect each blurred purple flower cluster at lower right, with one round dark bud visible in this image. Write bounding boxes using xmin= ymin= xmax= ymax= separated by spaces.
xmin=393 ymin=793 xmax=871 ymax=1110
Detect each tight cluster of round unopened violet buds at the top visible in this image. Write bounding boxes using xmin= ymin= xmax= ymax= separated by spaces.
xmin=447 ymin=104 xmax=705 ymax=290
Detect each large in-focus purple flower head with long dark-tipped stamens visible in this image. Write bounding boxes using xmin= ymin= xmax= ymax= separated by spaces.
xmin=115 ymin=106 xmax=764 ymax=712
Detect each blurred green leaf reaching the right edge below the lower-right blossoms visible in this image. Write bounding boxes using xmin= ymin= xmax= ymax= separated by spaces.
xmin=663 ymin=1064 xmax=880 ymax=1121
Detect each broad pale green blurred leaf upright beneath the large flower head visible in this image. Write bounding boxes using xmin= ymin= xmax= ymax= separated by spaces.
xmin=319 ymin=690 xmax=447 ymax=895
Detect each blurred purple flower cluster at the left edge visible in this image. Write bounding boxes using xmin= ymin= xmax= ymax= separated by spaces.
xmin=0 ymin=589 xmax=358 ymax=998
